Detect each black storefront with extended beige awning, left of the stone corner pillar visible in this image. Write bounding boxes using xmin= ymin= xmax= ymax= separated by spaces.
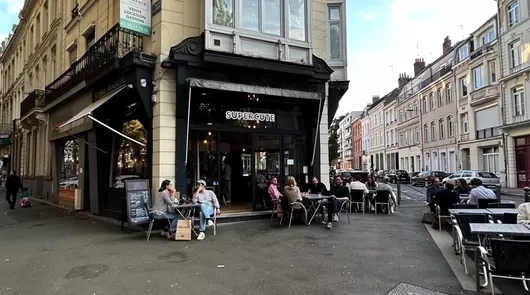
xmin=43 ymin=25 xmax=156 ymax=217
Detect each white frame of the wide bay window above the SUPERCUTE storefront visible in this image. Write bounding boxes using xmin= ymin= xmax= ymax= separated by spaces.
xmin=204 ymin=0 xmax=313 ymax=44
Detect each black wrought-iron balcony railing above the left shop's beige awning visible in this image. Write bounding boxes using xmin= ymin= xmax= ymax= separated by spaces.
xmin=45 ymin=24 xmax=143 ymax=104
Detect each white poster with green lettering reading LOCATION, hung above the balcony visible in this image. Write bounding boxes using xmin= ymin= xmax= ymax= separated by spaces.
xmin=120 ymin=0 xmax=151 ymax=36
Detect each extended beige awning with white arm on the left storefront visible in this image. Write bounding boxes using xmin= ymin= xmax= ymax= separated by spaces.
xmin=57 ymin=85 xmax=145 ymax=146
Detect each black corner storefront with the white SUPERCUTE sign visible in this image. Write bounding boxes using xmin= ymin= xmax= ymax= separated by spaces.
xmin=162 ymin=35 xmax=348 ymax=211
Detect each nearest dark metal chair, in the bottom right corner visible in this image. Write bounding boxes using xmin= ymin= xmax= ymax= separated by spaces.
xmin=476 ymin=239 xmax=530 ymax=295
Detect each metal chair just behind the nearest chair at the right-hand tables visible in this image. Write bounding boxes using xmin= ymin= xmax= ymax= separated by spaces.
xmin=454 ymin=214 xmax=489 ymax=274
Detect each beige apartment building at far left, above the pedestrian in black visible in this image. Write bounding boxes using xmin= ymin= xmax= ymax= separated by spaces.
xmin=0 ymin=0 xmax=62 ymax=190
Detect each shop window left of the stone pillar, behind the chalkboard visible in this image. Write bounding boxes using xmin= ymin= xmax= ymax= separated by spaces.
xmin=110 ymin=120 xmax=148 ymax=188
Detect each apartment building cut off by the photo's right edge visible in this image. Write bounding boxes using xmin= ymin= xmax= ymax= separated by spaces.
xmin=496 ymin=0 xmax=530 ymax=187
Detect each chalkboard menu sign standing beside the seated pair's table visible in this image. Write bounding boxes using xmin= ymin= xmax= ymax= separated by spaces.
xmin=125 ymin=179 xmax=151 ymax=226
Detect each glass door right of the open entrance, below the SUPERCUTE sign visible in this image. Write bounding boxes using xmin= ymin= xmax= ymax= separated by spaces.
xmin=252 ymin=134 xmax=285 ymax=210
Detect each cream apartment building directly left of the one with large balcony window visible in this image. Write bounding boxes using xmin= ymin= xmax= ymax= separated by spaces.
xmin=414 ymin=38 xmax=458 ymax=172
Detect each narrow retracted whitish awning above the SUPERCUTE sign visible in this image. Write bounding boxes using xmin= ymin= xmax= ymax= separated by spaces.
xmin=189 ymin=78 xmax=322 ymax=100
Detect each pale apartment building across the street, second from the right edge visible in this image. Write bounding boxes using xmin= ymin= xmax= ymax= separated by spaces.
xmin=449 ymin=16 xmax=506 ymax=185
